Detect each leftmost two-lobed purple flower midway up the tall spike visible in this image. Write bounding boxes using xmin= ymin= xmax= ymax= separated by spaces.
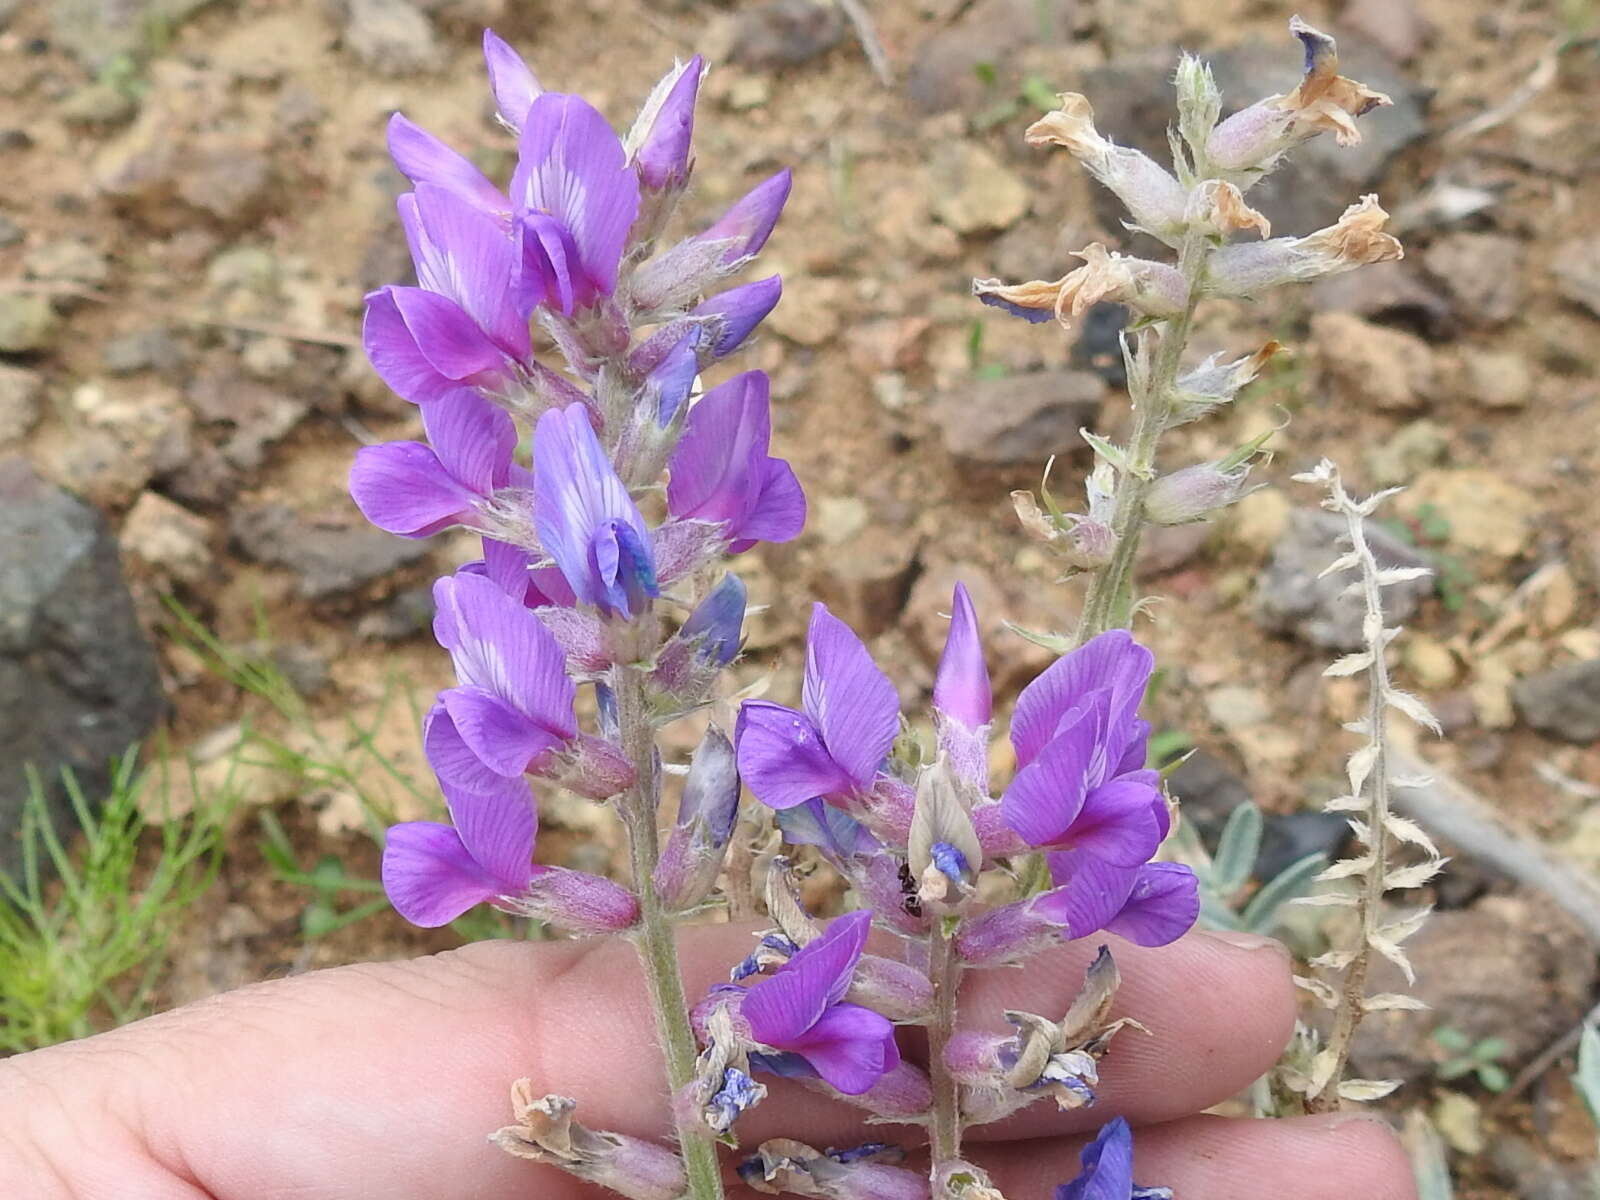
xmin=350 ymin=392 xmax=517 ymax=538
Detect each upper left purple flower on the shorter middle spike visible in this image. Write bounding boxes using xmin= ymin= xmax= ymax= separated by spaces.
xmin=734 ymin=605 xmax=899 ymax=808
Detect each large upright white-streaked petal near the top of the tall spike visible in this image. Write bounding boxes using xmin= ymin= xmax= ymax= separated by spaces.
xmin=512 ymin=91 xmax=638 ymax=294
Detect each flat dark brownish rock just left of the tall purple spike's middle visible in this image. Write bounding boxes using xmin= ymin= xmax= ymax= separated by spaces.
xmin=229 ymin=504 xmax=429 ymax=600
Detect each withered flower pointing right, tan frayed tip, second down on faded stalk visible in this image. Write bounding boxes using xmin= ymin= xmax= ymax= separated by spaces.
xmin=1206 ymin=195 xmax=1405 ymax=298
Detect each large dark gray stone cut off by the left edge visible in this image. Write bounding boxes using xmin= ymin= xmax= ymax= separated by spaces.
xmin=0 ymin=456 xmax=163 ymax=870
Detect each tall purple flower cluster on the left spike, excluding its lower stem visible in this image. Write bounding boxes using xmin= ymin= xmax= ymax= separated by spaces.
xmin=350 ymin=32 xmax=805 ymax=931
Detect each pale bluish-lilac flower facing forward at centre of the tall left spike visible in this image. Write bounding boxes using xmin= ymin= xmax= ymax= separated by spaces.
xmin=533 ymin=405 xmax=654 ymax=606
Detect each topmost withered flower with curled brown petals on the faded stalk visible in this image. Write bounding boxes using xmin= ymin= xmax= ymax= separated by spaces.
xmin=1206 ymin=16 xmax=1392 ymax=178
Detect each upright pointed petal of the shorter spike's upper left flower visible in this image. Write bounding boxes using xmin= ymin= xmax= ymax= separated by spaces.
xmin=803 ymin=605 xmax=899 ymax=787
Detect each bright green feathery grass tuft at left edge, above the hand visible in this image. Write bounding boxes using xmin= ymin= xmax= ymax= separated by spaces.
xmin=0 ymin=750 xmax=232 ymax=1053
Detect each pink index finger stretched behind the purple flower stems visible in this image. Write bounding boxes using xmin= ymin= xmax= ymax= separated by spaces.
xmin=8 ymin=926 xmax=1283 ymax=1197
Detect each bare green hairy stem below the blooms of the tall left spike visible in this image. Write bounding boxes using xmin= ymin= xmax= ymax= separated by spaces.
xmin=614 ymin=666 xmax=723 ymax=1200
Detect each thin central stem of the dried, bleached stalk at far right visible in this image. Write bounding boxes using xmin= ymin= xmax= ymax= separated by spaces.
xmin=1306 ymin=485 xmax=1389 ymax=1112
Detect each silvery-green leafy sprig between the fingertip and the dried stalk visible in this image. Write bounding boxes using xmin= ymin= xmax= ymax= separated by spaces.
xmin=1174 ymin=800 xmax=1328 ymax=934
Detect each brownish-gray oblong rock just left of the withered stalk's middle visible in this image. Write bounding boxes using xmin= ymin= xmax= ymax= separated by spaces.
xmin=933 ymin=371 xmax=1106 ymax=466
